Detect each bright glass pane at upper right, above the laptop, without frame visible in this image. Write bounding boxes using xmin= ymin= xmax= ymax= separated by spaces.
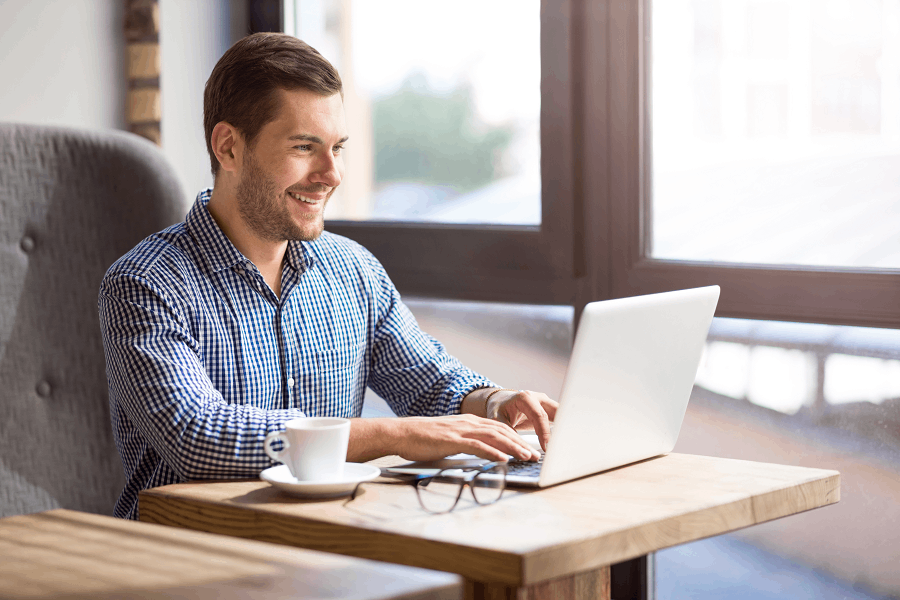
xmin=651 ymin=0 xmax=900 ymax=268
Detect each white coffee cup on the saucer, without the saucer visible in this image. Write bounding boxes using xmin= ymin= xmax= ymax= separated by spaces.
xmin=264 ymin=417 xmax=350 ymax=481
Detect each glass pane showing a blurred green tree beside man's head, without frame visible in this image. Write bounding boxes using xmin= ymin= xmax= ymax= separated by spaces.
xmin=285 ymin=0 xmax=541 ymax=225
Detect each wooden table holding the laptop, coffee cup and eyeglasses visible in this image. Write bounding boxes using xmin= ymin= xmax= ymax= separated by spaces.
xmin=140 ymin=454 xmax=840 ymax=599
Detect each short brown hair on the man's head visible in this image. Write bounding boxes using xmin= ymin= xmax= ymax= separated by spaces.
xmin=203 ymin=33 xmax=343 ymax=177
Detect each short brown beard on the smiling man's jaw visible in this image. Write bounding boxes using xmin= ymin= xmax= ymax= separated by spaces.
xmin=236 ymin=152 xmax=324 ymax=242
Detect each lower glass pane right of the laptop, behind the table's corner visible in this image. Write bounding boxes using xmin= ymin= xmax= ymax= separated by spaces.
xmin=656 ymin=318 xmax=900 ymax=600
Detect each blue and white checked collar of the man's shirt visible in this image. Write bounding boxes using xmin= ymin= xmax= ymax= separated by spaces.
xmin=185 ymin=188 xmax=314 ymax=273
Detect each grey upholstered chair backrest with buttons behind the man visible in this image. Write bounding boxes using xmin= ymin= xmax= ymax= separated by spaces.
xmin=0 ymin=123 xmax=184 ymax=517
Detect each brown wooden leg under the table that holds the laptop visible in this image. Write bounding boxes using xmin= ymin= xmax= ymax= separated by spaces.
xmin=464 ymin=567 xmax=610 ymax=600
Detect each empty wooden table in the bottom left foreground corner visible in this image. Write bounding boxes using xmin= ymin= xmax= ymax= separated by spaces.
xmin=0 ymin=510 xmax=462 ymax=600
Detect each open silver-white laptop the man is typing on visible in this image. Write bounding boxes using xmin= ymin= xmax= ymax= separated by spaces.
xmin=386 ymin=286 xmax=719 ymax=487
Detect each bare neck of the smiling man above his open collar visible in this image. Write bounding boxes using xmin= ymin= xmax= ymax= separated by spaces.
xmin=207 ymin=188 xmax=288 ymax=296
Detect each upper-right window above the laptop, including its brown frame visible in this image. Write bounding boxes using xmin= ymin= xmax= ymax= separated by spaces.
xmin=600 ymin=0 xmax=900 ymax=327
